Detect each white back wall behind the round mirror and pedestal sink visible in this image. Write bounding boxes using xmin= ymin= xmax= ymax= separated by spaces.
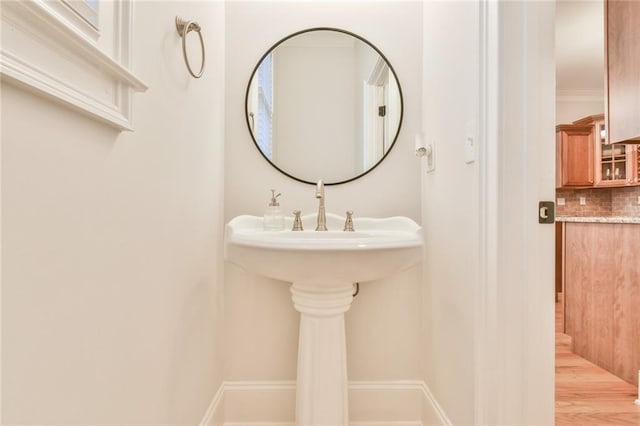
xmin=225 ymin=2 xmax=422 ymax=390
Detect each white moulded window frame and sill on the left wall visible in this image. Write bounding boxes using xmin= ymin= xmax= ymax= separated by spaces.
xmin=0 ymin=0 xmax=147 ymax=130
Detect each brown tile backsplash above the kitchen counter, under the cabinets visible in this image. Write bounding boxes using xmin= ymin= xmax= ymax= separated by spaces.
xmin=556 ymin=186 xmax=640 ymax=217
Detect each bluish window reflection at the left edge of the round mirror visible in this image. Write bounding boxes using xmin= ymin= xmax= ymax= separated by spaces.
xmin=248 ymin=54 xmax=274 ymax=160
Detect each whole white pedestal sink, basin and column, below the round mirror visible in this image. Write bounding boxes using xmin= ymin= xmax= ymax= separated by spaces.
xmin=225 ymin=213 xmax=424 ymax=426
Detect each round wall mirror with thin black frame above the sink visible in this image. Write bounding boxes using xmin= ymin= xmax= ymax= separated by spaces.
xmin=246 ymin=28 xmax=402 ymax=185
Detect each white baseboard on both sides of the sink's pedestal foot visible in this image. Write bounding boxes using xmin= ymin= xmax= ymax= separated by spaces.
xmin=200 ymin=380 xmax=451 ymax=426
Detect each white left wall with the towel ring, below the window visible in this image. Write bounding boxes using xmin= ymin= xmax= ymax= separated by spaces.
xmin=2 ymin=2 xmax=225 ymax=424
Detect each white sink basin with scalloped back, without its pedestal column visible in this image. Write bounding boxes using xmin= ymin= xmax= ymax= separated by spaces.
xmin=225 ymin=213 xmax=424 ymax=285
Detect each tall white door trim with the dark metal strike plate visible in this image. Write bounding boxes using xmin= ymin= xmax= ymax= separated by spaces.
xmin=475 ymin=0 xmax=555 ymax=424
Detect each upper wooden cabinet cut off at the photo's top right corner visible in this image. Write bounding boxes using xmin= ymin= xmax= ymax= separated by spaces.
xmin=604 ymin=0 xmax=640 ymax=143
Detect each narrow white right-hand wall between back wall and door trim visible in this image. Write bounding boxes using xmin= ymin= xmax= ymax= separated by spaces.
xmin=422 ymin=2 xmax=479 ymax=425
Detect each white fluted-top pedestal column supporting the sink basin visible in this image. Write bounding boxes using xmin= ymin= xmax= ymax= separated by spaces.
xmin=291 ymin=283 xmax=353 ymax=426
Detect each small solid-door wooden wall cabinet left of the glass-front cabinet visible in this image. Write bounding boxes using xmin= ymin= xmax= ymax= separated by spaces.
xmin=556 ymin=124 xmax=594 ymax=188
